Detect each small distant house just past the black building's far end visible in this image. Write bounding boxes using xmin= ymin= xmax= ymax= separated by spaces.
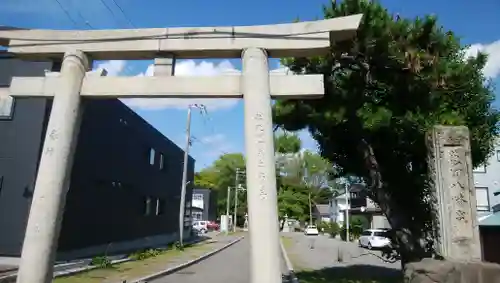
xmin=191 ymin=187 xmax=217 ymax=221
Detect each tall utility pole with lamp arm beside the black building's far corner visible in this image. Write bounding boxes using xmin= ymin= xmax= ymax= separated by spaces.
xmin=179 ymin=104 xmax=206 ymax=247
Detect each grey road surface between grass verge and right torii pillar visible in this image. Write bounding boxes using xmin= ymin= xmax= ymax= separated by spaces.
xmin=151 ymin=238 xmax=290 ymax=283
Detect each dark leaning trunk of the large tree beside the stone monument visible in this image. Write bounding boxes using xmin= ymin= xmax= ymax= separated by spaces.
xmin=359 ymin=140 xmax=428 ymax=268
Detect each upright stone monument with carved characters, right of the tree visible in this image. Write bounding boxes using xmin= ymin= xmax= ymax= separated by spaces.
xmin=428 ymin=126 xmax=481 ymax=261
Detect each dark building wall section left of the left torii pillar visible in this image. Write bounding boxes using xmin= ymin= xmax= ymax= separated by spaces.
xmin=0 ymin=98 xmax=46 ymax=256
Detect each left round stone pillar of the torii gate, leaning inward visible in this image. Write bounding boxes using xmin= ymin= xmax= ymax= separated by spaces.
xmin=17 ymin=51 xmax=89 ymax=283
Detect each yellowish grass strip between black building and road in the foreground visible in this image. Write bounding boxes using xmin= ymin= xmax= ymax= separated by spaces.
xmin=53 ymin=243 xmax=212 ymax=283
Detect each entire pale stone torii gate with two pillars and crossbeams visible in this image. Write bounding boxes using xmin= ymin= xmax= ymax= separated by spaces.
xmin=0 ymin=15 xmax=362 ymax=283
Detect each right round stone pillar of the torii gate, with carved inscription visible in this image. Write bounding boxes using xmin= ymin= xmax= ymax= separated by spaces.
xmin=241 ymin=48 xmax=282 ymax=283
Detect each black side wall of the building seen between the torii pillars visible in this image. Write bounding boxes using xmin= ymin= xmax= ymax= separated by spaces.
xmin=59 ymin=100 xmax=194 ymax=251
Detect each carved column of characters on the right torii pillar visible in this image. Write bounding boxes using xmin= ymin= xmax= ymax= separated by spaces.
xmin=253 ymin=112 xmax=267 ymax=200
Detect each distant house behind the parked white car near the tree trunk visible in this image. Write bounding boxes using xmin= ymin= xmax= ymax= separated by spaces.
xmin=330 ymin=184 xmax=390 ymax=231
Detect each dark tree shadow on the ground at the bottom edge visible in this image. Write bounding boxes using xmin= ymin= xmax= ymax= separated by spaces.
xmin=295 ymin=265 xmax=403 ymax=283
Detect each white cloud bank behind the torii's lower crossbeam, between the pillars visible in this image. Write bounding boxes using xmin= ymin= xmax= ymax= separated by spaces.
xmin=124 ymin=60 xmax=240 ymax=111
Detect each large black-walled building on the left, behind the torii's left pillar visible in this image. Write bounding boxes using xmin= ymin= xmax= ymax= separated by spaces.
xmin=0 ymin=56 xmax=194 ymax=258
